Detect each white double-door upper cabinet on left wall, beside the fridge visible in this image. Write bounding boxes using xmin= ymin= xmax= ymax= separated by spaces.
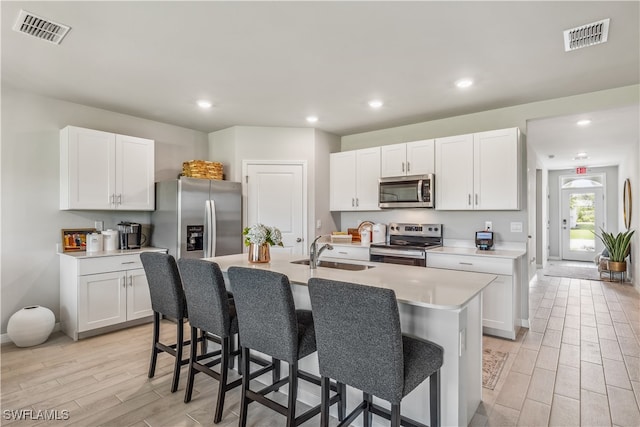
xmin=60 ymin=126 xmax=155 ymax=210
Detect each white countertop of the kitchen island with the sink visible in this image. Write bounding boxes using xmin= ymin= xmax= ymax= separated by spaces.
xmin=205 ymin=253 xmax=496 ymax=309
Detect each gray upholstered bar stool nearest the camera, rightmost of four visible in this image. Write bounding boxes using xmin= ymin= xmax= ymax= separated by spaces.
xmin=309 ymin=278 xmax=443 ymax=427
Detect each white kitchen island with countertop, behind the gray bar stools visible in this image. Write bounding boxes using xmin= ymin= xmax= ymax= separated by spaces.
xmin=206 ymin=254 xmax=496 ymax=426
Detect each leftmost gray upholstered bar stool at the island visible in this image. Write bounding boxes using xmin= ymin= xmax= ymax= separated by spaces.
xmin=140 ymin=252 xmax=195 ymax=393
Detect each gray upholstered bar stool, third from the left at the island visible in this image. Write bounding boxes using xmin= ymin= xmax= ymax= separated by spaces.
xmin=228 ymin=267 xmax=344 ymax=427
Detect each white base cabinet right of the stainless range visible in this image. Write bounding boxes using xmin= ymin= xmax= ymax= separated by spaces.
xmin=427 ymin=251 xmax=520 ymax=340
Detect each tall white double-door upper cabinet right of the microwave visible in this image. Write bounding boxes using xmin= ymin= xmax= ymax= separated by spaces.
xmin=435 ymin=128 xmax=521 ymax=210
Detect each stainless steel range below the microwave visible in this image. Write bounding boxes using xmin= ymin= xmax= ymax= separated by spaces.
xmin=369 ymin=223 xmax=442 ymax=267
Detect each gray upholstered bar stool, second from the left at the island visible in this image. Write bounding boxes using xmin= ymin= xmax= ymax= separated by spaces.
xmin=178 ymin=258 xmax=242 ymax=424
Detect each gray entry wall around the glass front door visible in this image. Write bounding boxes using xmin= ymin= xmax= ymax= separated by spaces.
xmin=548 ymin=166 xmax=619 ymax=259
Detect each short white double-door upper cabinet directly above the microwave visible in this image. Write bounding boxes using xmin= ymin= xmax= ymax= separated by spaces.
xmin=380 ymin=139 xmax=435 ymax=178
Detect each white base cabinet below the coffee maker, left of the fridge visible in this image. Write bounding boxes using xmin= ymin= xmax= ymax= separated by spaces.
xmin=60 ymin=249 xmax=163 ymax=340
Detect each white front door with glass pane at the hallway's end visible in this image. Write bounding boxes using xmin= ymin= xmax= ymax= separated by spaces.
xmin=560 ymin=188 xmax=605 ymax=261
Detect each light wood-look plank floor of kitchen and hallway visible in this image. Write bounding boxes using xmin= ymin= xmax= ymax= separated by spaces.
xmin=0 ymin=266 xmax=640 ymax=427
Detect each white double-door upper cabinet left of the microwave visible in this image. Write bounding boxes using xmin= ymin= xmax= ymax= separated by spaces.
xmin=329 ymin=147 xmax=380 ymax=211
